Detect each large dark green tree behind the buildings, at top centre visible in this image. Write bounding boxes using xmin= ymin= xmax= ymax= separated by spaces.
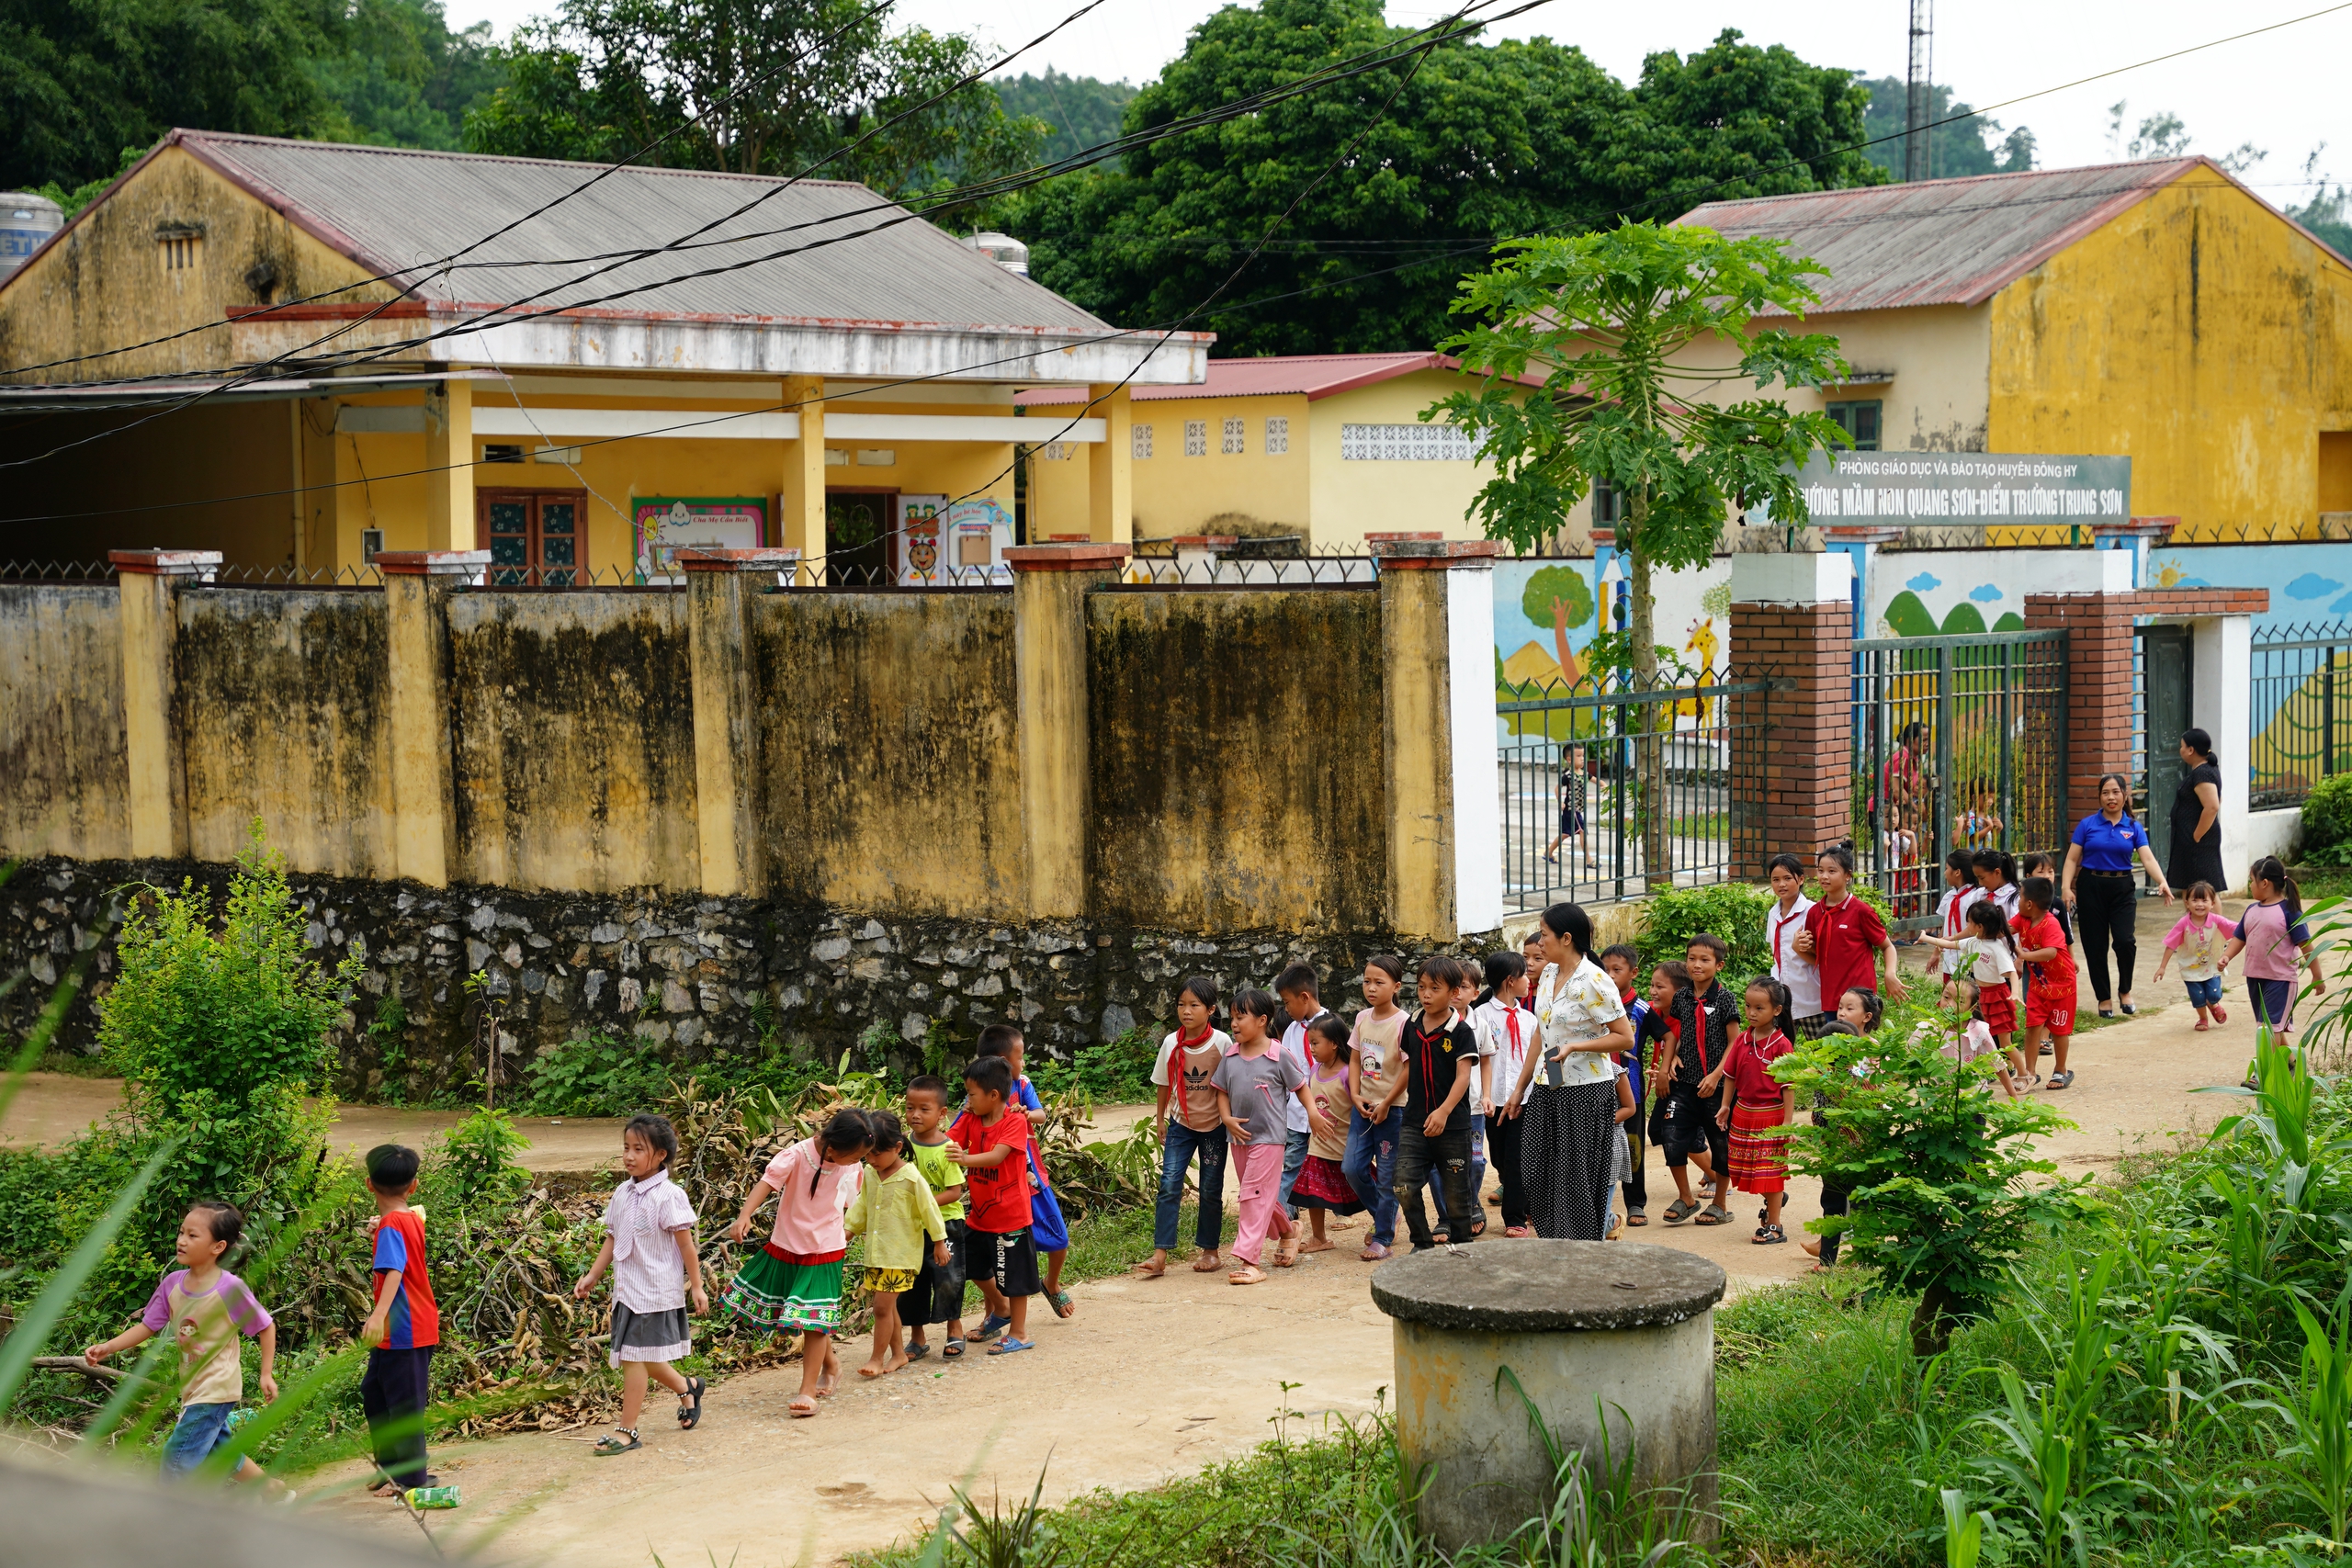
xmin=1002 ymin=0 xmax=1884 ymax=355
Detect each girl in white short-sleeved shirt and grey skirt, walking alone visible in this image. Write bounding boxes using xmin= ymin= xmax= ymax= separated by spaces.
xmin=571 ymin=1117 xmax=710 ymax=1458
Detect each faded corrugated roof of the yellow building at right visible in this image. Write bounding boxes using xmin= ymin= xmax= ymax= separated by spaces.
xmin=1677 ymin=157 xmax=2227 ymax=310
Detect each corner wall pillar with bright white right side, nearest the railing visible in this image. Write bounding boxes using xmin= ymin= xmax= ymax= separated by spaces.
xmin=1371 ymin=536 xmax=1503 ymax=942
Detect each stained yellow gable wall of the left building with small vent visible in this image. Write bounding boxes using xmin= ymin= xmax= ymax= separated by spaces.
xmin=0 ymin=148 xmax=393 ymax=385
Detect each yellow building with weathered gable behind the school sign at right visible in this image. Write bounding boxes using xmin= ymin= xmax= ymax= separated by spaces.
xmin=1665 ymin=157 xmax=2352 ymax=543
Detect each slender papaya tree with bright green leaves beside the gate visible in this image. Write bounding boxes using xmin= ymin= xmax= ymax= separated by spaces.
xmin=1423 ymin=223 xmax=1847 ymax=882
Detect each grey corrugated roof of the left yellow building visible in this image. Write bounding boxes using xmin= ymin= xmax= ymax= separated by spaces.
xmin=172 ymin=131 xmax=1110 ymax=332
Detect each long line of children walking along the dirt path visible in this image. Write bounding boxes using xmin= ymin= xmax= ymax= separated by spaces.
xmin=101 ymin=844 xmax=2326 ymax=1506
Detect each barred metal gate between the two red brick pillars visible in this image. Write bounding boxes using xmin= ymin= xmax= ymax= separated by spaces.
xmin=1853 ymin=632 xmax=2067 ymax=931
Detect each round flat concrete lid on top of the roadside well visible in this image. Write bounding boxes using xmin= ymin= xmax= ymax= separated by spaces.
xmin=1371 ymin=1241 xmax=1724 ymax=1333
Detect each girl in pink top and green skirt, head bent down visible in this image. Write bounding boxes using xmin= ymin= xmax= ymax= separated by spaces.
xmin=722 ymin=1110 xmax=873 ymax=1416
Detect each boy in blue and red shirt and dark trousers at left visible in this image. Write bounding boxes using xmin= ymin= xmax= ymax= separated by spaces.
xmin=360 ymin=1143 xmax=440 ymax=1495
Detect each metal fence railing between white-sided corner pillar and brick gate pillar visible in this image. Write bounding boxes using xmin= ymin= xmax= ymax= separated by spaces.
xmin=1494 ymin=674 xmax=1769 ymax=912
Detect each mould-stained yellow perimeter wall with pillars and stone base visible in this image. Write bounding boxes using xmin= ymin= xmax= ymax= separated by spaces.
xmin=0 ymin=543 xmax=1500 ymax=1086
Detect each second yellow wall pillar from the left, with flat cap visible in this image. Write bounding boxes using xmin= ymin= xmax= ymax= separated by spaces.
xmin=377 ymin=550 xmax=489 ymax=886
